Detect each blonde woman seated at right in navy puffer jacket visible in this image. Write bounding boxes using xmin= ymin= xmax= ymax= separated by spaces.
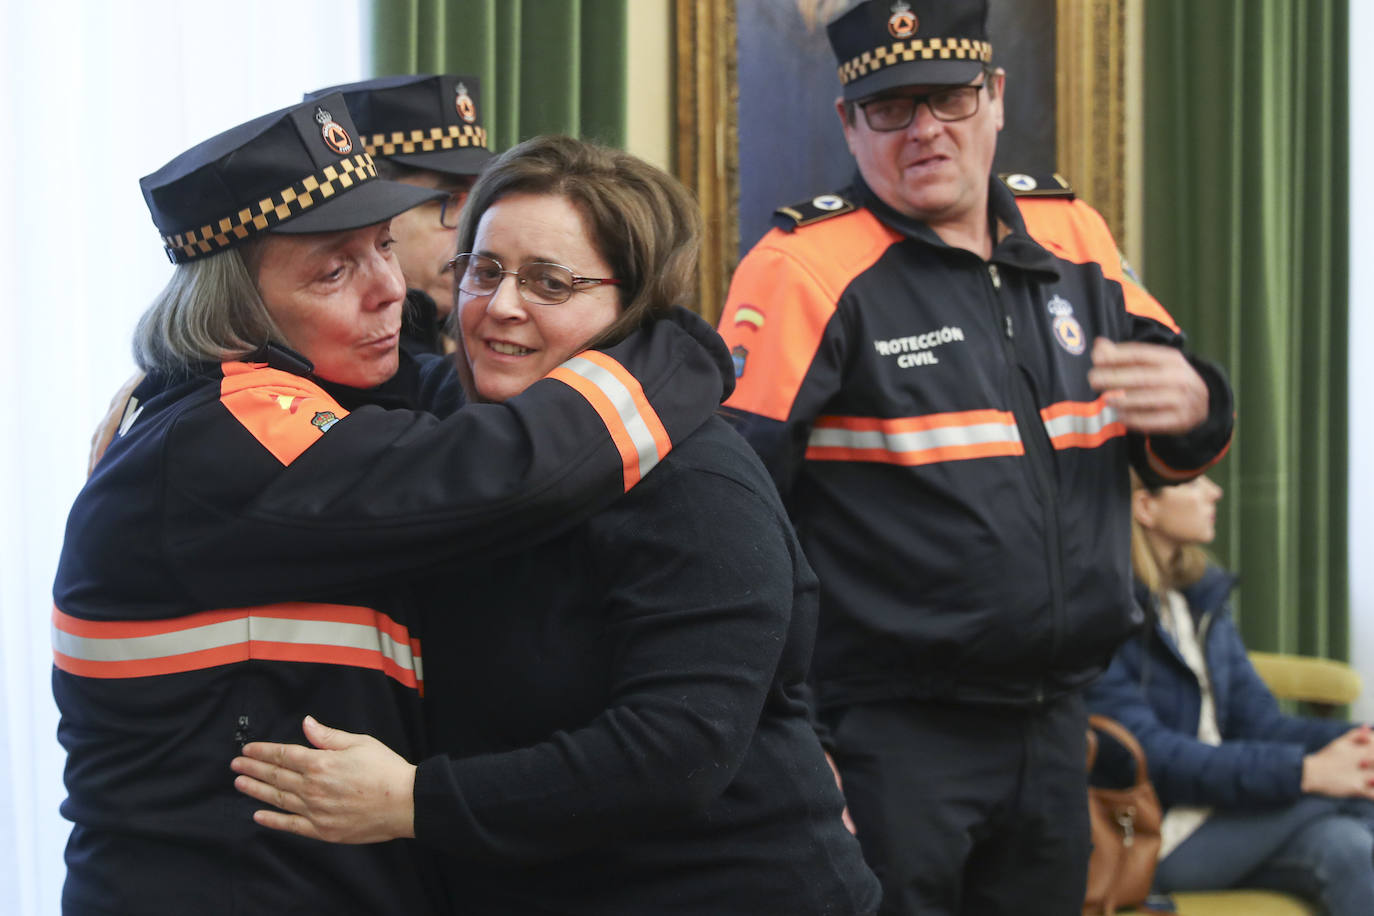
xmin=1088 ymin=477 xmax=1374 ymax=916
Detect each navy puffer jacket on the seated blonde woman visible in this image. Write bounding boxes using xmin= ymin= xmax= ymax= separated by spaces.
xmin=1088 ymin=566 xmax=1349 ymax=808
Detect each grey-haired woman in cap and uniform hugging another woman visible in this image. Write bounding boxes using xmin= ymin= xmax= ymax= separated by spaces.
xmin=52 ymin=95 xmax=728 ymax=916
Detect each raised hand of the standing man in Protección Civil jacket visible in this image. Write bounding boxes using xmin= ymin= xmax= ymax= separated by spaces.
xmin=1088 ymin=338 xmax=1208 ymax=435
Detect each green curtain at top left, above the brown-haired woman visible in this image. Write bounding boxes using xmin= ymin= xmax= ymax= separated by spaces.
xmin=372 ymin=0 xmax=632 ymax=151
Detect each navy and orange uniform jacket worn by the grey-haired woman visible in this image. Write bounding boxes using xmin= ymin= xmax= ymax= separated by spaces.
xmin=52 ymin=313 xmax=725 ymax=915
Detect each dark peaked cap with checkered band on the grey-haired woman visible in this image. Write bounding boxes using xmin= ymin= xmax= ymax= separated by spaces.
xmin=139 ymin=95 xmax=442 ymax=264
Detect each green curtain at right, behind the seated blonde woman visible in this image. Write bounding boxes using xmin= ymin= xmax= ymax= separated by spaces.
xmin=1143 ymin=0 xmax=1349 ymax=659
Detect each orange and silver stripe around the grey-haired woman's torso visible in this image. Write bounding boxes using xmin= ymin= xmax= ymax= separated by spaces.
xmin=52 ymin=602 xmax=425 ymax=689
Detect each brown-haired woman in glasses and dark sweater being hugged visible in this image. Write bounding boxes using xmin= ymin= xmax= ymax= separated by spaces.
xmin=234 ymin=137 xmax=879 ymax=916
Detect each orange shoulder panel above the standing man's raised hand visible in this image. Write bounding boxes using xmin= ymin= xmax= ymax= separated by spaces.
xmin=1017 ymin=198 xmax=1179 ymax=332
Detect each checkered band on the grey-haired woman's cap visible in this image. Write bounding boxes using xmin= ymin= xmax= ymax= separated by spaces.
xmin=162 ymin=152 xmax=376 ymax=264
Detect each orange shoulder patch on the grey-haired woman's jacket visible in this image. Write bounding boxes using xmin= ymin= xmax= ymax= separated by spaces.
xmin=220 ymin=363 xmax=348 ymax=464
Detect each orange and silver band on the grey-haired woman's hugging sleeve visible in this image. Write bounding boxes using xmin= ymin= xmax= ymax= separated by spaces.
xmin=548 ymin=350 xmax=672 ymax=492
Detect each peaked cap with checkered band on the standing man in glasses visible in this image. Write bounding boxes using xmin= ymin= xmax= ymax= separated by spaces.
xmin=826 ymin=0 xmax=992 ymax=102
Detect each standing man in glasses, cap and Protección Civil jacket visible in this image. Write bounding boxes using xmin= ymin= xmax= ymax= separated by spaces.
xmin=720 ymin=0 xmax=1232 ymax=915
